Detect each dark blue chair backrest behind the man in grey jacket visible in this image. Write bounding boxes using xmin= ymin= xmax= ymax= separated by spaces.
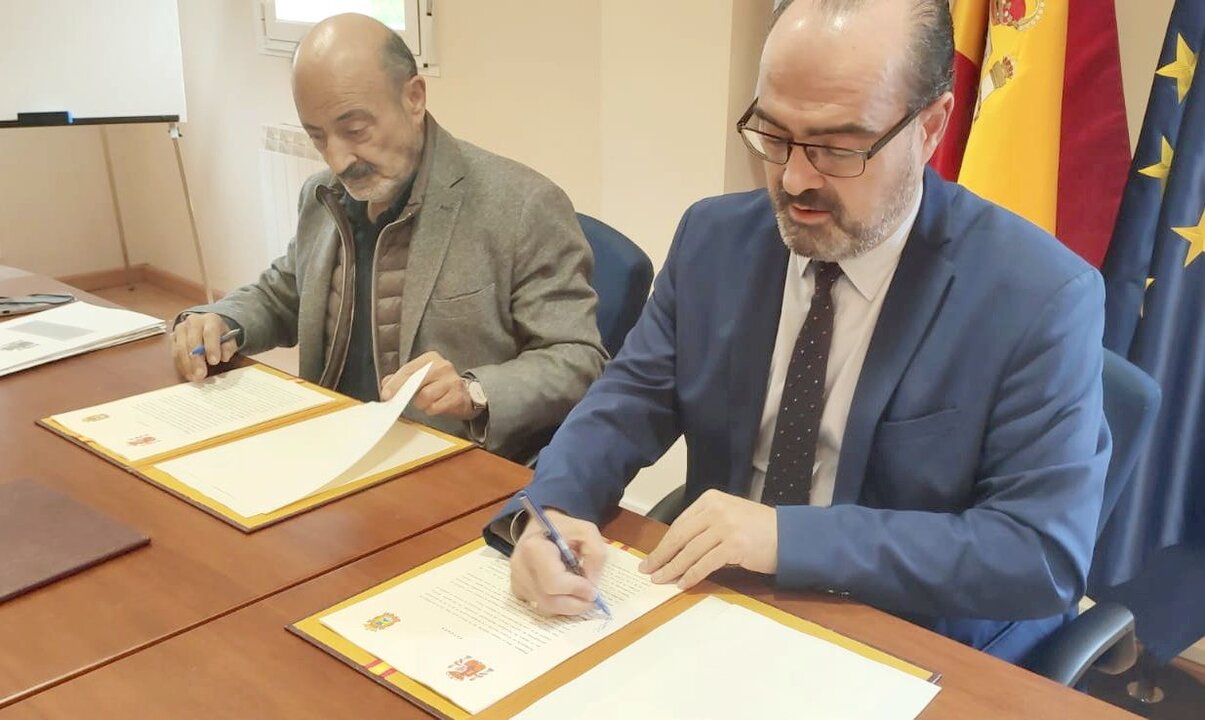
xmin=577 ymin=213 xmax=653 ymax=358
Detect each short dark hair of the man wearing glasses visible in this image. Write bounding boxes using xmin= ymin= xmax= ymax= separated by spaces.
xmin=770 ymin=0 xmax=954 ymax=110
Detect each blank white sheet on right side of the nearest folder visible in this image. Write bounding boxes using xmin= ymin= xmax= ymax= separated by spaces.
xmin=516 ymin=597 xmax=940 ymax=720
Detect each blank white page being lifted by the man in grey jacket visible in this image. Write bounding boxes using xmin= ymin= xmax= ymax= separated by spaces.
xmin=155 ymin=364 xmax=430 ymax=517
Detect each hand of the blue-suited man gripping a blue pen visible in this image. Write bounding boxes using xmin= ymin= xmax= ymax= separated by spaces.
xmin=511 ymin=509 xmax=607 ymax=615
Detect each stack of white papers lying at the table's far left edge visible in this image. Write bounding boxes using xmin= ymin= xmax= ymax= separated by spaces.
xmin=0 ymin=301 xmax=164 ymax=376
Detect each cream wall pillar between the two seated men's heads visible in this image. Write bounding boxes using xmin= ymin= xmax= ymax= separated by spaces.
xmin=600 ymin=0 xmax=731 ymax=267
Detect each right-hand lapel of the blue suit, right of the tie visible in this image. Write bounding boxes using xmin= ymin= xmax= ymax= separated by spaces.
xmin=833 ymin=171 xmax=954 ymax=504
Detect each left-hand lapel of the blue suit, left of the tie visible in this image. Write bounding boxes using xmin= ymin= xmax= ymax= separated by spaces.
xmin=727 ymin=211 xmax=790 ymax=496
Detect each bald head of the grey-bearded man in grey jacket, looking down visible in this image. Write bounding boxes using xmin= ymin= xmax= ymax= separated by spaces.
xmin=293 ymin=13 xmax=427 ymax=218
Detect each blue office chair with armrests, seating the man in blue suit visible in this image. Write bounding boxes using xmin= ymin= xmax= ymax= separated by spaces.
xmin=648 ymin=350 xmax=1160 ymax=686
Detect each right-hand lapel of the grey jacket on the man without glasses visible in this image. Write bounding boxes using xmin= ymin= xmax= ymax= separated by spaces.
xmin=399 ymin=121 xmax=465 ymax=364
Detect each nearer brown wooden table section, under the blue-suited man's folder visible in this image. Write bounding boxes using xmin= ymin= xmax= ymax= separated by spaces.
xmin=0 ymin=508 xmax=1133 ymax=720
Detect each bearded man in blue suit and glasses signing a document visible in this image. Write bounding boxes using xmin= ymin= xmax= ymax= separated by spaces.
xmin=486 ymin=0 xmax=1111 ymax=661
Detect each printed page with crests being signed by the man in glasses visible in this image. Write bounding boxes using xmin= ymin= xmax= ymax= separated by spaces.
xmin=322 ymin=545 xmax=681 ymax=718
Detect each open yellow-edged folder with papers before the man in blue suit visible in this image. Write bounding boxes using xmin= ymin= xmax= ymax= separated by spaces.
xmin=290 ymin=539 xmax=940 ymax=720
